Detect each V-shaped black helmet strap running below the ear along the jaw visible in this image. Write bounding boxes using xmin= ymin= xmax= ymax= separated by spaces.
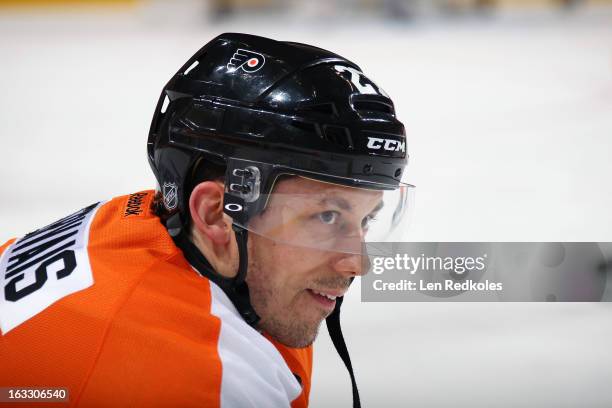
xmin=166 ymin=214 xmax=259 ymax=327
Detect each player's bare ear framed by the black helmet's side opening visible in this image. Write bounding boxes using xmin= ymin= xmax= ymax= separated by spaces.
xmin=189 ymin=181 xmax=232 ymax=245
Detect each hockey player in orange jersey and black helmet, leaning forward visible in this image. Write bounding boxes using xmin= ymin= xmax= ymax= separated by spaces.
xmin=0 ymin=34 xmax=409 ymax=407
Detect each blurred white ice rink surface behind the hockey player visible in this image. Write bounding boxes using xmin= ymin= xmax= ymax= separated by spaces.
xmin=0 ymin=0 xmax=612 ymax=408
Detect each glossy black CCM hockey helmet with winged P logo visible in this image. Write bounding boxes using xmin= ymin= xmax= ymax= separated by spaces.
xmin=148 ymin=33 xmax=407 ymax=242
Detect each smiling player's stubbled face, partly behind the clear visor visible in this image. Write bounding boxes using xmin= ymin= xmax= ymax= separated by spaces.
xmin=247 ymin=177 xmax=382 ymax=347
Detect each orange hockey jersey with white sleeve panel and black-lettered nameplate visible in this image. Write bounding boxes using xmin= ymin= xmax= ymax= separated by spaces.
xmin=0 ymin=191 xmax=312 ymax=407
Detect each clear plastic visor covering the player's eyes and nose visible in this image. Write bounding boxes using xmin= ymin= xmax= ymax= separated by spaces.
xmin=236 ymin=176 xmax=414 ymax=254
